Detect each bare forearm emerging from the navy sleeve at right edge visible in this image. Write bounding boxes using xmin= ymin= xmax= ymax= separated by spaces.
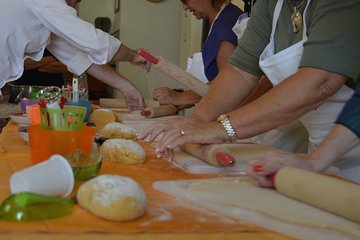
xmin=305 ymin=124 xmax=359 ymax=172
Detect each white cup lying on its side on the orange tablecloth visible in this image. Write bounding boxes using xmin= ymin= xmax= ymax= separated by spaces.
xmin=10 ymin=154 xmax=74 ymax=197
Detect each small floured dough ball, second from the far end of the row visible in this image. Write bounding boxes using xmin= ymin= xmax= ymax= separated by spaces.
xmin=101 ymin=122 xmax=137 ymax=140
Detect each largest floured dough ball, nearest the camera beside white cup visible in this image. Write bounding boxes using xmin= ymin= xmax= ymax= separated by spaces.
xmin=76 ymin=174 xmax=146 ymax=221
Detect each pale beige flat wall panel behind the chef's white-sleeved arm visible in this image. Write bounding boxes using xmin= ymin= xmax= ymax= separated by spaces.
xmin=115 ymin=0 xmax=182 ymax=99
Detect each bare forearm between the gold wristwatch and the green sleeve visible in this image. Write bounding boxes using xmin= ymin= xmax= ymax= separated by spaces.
xmin=230 ymin=68 xmax=346 ymax=138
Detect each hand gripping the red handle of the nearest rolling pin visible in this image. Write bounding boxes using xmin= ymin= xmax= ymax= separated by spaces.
xmin=247 ymin=152 xmax=314 ymax=187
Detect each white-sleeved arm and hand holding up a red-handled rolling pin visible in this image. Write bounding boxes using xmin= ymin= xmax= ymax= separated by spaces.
xmin=25 ymin=0 xmax=149 ymax=75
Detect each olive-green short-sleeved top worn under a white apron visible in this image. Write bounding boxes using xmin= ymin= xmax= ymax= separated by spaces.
xmin=229 ymin=0 xmax=360 ymax=81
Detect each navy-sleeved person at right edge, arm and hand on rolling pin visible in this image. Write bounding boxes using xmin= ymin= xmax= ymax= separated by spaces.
xmin=248 ymin=84 xmax=360 ymax=187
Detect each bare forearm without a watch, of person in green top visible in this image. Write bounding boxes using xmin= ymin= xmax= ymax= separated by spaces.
xmin=191 ymin=64 xmax=260 ymax=122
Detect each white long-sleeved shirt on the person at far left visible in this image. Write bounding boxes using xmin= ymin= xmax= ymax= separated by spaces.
xmin=0 ymin=0 xmax=121 ymax=88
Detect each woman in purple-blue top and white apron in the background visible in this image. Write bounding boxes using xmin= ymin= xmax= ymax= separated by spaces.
xmin=153 ymin=0 xmax=242 ymax=108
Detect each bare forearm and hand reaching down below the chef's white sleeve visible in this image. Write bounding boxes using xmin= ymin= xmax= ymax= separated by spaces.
xmin=87 ymin=64 xmax=145 ymax=111
